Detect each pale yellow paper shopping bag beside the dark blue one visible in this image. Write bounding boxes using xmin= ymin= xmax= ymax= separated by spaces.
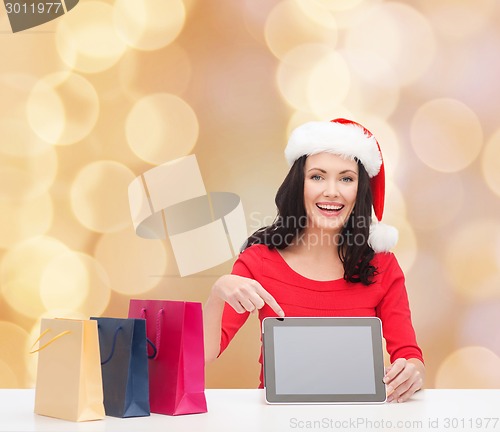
xmin=32 ymin=319 xmax=104 ymax=421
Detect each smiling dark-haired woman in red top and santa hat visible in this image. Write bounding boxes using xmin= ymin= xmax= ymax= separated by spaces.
xmin=204 ymin=119 xmax=425 ymax=402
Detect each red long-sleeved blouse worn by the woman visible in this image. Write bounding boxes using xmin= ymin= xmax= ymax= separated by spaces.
xmin=220 ymin=245 xmax=423 ymax=387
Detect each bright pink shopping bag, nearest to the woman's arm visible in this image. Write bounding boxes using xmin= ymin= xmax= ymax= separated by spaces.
xmin=129 ymin=300 xmax=207 ymax=415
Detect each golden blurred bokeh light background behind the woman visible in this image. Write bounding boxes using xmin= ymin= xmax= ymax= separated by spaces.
xmin=0 ymin=0 xmax=500 ymax=388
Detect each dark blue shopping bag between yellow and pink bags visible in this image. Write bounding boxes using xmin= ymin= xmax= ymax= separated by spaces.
xmin=90 ymin=317 xmax=149 ymax=417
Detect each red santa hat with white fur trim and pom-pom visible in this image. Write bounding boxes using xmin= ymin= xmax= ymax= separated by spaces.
xmin=285 ymin=118 xmax=398 ymax=252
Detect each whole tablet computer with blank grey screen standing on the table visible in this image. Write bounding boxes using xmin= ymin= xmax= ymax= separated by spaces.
xmin=262 ymin=317 xmax=386 ymax=403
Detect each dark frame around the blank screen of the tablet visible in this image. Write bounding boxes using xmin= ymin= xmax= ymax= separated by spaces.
xmin=262 ymin=317 xmax=386 ymax=404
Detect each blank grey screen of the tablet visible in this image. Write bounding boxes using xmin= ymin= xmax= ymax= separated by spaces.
xmin=274 ymin=327 xmax=375 ymax=394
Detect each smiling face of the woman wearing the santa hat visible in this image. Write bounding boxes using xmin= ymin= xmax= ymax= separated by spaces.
xmin=304 ymin=153 xmax=358 ymax=233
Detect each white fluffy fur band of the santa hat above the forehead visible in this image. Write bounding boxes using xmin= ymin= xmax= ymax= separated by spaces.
xmin=285 ymin=121 xmax=382 ymax=177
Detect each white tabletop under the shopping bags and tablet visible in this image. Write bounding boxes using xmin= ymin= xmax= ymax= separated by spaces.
xmin=0 ymin=389 xmax=500 ymax=432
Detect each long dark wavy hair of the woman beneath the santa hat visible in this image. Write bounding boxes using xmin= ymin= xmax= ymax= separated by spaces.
xmin=242 ymin=156 xmax=376 ymax=285
